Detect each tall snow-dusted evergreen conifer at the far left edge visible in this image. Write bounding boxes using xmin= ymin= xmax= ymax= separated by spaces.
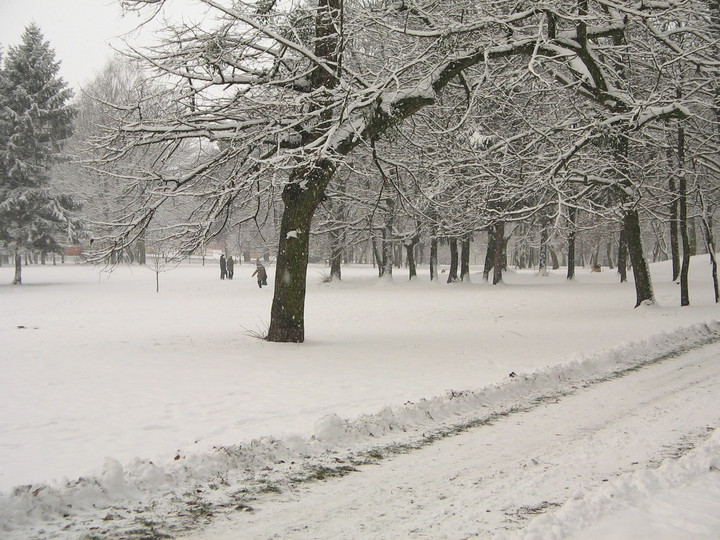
xmin=0 ymin=24 xmax=79 ymax=284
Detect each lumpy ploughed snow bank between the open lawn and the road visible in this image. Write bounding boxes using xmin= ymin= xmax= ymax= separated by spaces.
xmin=0 ymin=321 xmax=720 ymax=539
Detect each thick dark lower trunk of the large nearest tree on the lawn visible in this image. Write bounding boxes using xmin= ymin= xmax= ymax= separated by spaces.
xmin=267 ymin=161 xmax=335 ymax=343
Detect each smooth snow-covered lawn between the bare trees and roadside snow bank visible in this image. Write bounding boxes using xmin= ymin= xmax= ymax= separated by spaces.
xmin=0 ymin=257 xmax=718 ymax=530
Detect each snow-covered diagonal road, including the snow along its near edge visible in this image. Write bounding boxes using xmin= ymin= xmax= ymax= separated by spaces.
xmin=187 ymin=334 xmax=720 ymax=539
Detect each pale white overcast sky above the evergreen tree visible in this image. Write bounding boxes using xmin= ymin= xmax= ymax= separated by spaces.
xmin=0 ymin=0 xmax=208 ymax=90
